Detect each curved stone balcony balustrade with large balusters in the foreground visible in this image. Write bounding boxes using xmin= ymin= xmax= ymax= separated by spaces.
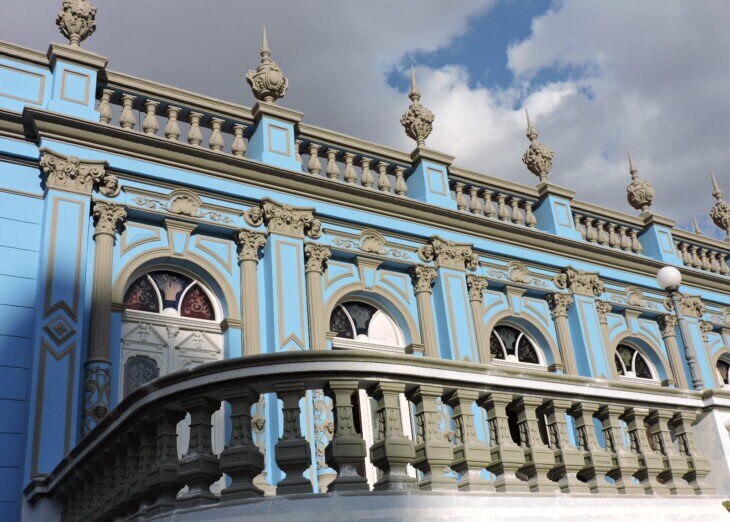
xmin=26 ymin=351 xmax=710 ymax=522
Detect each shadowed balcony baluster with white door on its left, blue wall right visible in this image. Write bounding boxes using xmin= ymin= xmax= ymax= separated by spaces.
xmin=220 ymin=386 xmax=264 ymax=500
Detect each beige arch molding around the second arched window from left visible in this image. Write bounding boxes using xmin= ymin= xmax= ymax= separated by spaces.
xmin=325 ymin=283 xmax=421 ymax=346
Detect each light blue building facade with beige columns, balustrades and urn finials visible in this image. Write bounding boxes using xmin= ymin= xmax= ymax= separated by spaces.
xmin=0 ymin=2 xmax=730 ymax=520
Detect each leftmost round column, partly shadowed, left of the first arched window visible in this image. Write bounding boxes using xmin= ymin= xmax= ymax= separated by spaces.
xmin=84 ymin=201 xmax=127 ymax=433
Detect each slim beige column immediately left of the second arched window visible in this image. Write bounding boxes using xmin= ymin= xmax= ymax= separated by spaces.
xmin=304 ymin=243 xmax=332 ymax=350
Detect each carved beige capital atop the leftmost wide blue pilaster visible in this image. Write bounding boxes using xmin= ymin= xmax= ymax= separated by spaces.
xmin=39 ymin=148 xmax=120 ymax=198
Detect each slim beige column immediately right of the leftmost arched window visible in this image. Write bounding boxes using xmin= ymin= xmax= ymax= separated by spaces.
xmin=235 ymin=230 xmax=266 ymax=355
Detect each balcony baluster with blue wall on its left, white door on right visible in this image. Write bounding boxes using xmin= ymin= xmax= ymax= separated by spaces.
xmin=325 ymin=380 xmax=370 ymax=491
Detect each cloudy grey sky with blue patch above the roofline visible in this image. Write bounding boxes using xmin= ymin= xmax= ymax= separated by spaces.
xmin=0 ymin=0 xmax=730 ymax=238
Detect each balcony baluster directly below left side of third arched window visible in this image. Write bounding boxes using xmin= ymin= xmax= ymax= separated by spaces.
xmin=479 ymin=393 xmax=529 ymax=493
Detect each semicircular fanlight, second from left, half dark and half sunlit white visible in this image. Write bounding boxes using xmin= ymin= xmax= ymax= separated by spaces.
xmin=329 ymin=301 xmax=404 ymax=351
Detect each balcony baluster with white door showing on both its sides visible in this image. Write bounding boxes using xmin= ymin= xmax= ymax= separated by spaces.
xmin=370 ymin=382 xmax=418 ymax=491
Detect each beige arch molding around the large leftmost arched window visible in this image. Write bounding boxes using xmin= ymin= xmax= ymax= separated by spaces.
xmin=112 ymin=248 xmax=240 ymax=320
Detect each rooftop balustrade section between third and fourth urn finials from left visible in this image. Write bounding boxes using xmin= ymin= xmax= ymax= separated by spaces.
xmin=451 ymin=179 xmax=537 ymax=228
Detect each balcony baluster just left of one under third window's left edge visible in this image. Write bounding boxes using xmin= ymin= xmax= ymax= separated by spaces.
xmin=444 ymin=389 xmax=493 ymax=491
